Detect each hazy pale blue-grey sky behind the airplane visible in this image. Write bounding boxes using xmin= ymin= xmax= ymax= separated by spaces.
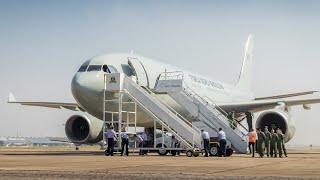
xmin=0 ymin=0 xmax=320 ymax=145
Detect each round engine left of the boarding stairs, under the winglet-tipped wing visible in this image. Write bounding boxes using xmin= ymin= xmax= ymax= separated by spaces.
xmin=65 ymin=114 xmax=103 ymax=143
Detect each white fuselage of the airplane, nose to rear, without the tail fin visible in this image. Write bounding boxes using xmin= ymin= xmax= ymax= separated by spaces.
xmin=71 ymin=54 xmax=253 ymax=125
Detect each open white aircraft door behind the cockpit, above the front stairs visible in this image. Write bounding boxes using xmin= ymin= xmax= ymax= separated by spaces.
xmin=128 ymin=57 xmax=149 ymax=87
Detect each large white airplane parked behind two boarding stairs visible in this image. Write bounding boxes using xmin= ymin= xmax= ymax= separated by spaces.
xmin=8 ymin=35 xmax=320 ymax=144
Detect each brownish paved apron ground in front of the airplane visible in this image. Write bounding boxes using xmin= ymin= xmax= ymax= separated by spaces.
xmin=0 ymin=147 xmax=320 ymax=180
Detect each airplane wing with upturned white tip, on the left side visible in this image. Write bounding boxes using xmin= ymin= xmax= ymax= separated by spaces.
xmin=8 ymin=93 xmax=85 ymax=111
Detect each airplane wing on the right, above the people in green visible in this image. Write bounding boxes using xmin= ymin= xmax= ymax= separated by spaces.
xmin=217 ymin=96 xmax=320 ymax=112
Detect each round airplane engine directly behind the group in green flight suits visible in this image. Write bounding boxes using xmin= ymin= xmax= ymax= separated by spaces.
xmin=256 ymin=109 xmax=296 ymax=142
